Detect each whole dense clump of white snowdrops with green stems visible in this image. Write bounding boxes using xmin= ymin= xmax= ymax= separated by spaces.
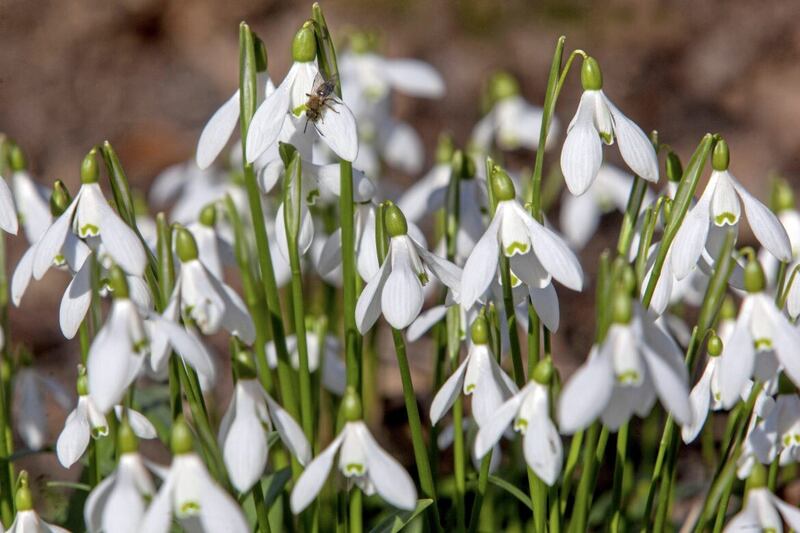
xmin=0 ymin=5 xmax=800 ymax=533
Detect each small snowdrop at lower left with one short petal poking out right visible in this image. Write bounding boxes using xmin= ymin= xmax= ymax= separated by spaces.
xmin=56 ymin=368 xmax=157 ymax=468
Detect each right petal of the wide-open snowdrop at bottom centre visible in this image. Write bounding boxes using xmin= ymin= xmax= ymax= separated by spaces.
xmin=354 ymin=422 xmax=417 ymax=511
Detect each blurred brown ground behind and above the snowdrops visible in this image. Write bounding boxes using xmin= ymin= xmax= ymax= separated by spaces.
xmin=0 ymin=0 xmax=800 ymax=512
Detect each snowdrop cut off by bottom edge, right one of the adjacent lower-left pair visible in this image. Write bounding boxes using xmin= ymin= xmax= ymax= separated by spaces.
xmin=139 ymin=420 xmax=250 ymax=533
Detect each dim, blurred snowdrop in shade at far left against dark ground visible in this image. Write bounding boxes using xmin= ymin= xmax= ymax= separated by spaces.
xmin=14 ymin=366 xmax=72 ymax=451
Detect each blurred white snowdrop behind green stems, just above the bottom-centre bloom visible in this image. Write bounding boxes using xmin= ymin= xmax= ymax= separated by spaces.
xmin=264 ymin=325 xmax=347 ymax=396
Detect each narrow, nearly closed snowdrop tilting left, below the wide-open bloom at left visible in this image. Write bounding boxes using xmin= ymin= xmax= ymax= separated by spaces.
xmin=86 ymin=267 xmax=150 ymax=413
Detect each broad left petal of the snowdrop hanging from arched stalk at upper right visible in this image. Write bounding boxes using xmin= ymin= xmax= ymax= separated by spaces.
xmin=561 ymin=92 xmax=603 ymax=195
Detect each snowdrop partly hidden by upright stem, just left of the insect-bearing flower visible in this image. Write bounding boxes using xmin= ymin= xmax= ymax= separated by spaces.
xmin=196 ymin=44 xmax=275 ymax=169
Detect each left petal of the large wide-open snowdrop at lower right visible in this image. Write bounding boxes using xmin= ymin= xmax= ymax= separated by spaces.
xmin=558 ymin=347 xmax=615 ymax=435
